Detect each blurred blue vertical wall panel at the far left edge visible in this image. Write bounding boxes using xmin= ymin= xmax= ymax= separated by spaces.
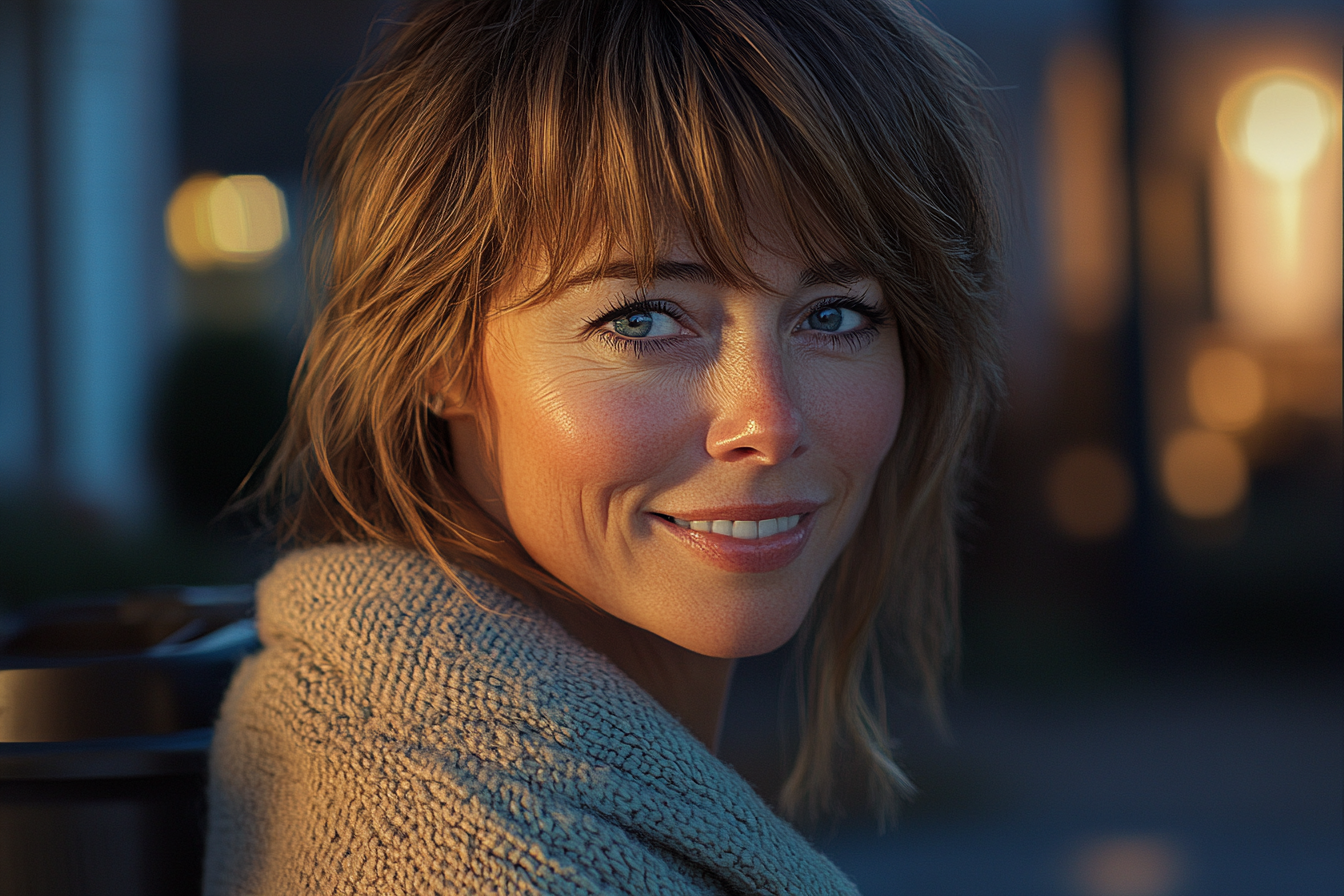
xmin=0 ymin=0 xmax=175 ymax=521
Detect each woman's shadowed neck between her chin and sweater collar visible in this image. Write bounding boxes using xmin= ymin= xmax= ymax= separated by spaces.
xmin=529 ymin=598 xmax=734 ymax=752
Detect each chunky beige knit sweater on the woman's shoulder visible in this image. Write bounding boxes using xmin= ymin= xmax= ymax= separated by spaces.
xmin=204 ymin=544 xmax=856 ymax=896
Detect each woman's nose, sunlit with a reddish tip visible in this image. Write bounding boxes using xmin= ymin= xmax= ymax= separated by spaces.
xmin=706 ymin=348 xmax=808 ymax=463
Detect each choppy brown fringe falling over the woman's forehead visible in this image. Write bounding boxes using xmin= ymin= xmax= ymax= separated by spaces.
xmin=488 ymin=3 xmax=892 ymax=301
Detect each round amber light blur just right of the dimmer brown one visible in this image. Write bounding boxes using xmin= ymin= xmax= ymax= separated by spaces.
xmin=1163 ymin=429 xmax=1249 ymax=519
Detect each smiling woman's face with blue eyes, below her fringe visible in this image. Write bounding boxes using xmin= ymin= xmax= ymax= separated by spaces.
xmin=449 ymin=222 xmax=905 ymax=657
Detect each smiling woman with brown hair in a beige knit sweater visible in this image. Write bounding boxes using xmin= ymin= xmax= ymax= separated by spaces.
xmin=206 ymin=0 xmax=999 ymax=893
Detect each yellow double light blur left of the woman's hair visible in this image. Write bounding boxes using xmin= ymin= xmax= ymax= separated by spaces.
xmin=164 ymin=173 xmax=289 ymax=270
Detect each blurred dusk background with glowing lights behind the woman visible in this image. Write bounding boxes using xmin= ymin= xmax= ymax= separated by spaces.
xmin=0 ymin=0 xmax=1344 ymax=896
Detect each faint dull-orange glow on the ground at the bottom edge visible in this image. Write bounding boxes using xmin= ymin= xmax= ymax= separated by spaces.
xmin=1073 ymin=837 xmax=1185 ymax=896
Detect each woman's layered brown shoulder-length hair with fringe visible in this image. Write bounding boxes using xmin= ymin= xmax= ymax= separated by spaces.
xmin=263 ymin=0 xmax=1001 ymax=815
